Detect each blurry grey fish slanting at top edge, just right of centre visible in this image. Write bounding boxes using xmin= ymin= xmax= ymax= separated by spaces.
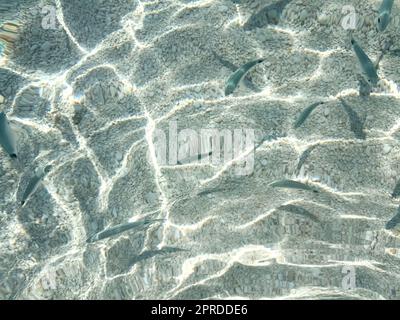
xmin=243 ymin=0 xmax=292 ymax=31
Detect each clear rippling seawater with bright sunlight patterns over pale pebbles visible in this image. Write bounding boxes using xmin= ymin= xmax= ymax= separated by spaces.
xmin=0 ymin=0 xmax=400 ymax=299
